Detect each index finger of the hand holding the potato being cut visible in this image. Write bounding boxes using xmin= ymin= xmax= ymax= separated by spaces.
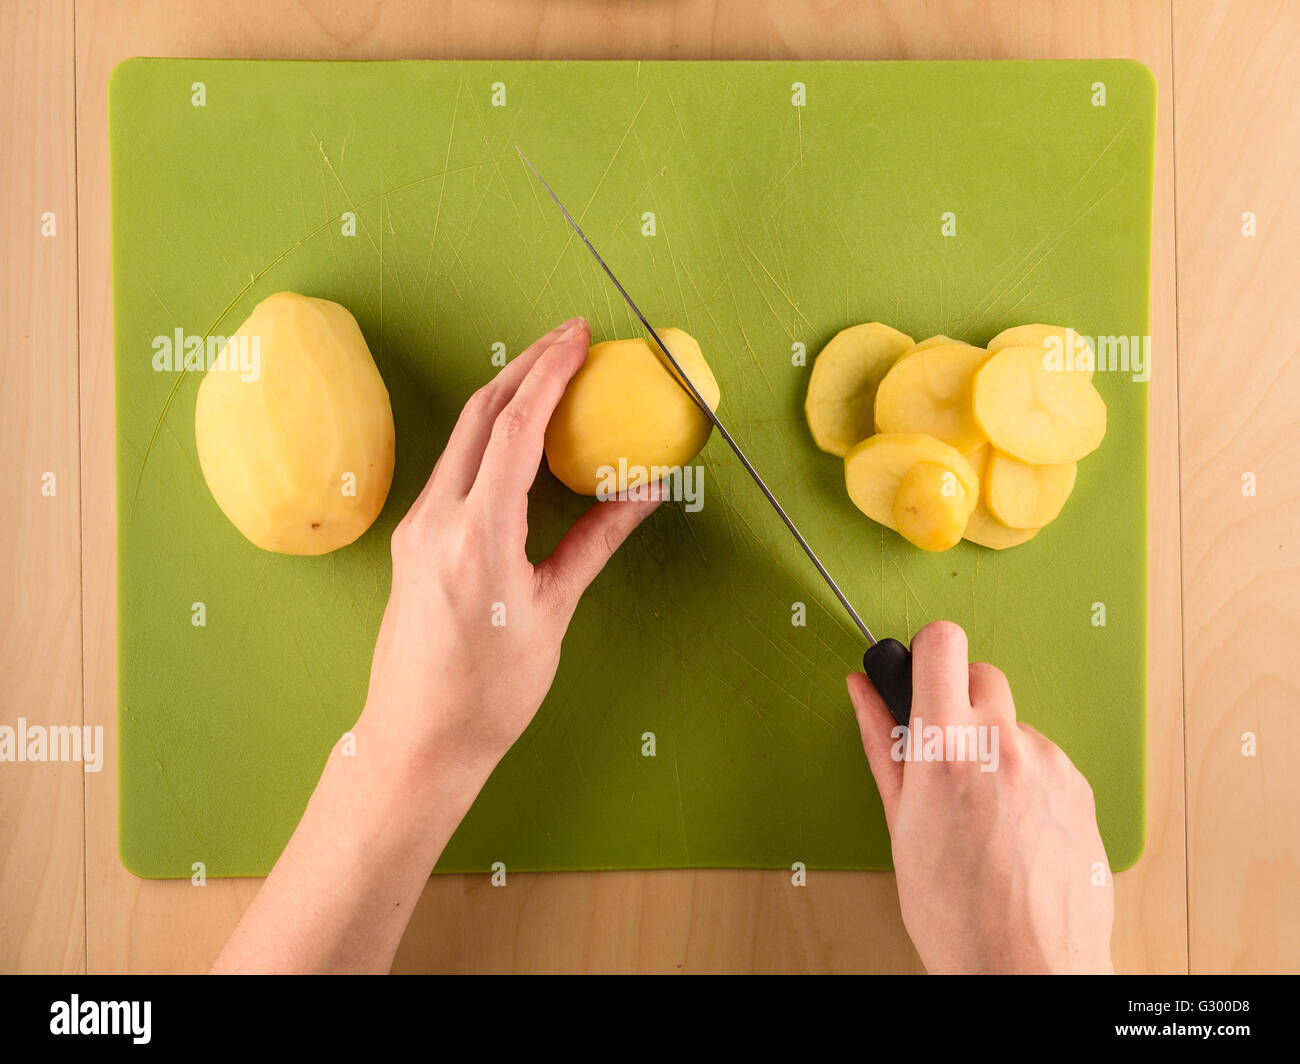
xmin=469 ymin=320 xmax=592 ymax=516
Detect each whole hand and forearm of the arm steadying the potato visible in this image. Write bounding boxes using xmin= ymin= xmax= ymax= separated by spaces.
xmin=213 ymin=319 xmax=657 ymax=972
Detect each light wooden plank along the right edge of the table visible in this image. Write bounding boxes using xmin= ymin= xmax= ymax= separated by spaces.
xmin=1174 ymin=0 xmax=1300 ymax=972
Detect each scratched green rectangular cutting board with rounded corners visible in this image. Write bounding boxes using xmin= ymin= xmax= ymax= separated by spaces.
xmin=109 ymin=59 xmax=1156 ymax=877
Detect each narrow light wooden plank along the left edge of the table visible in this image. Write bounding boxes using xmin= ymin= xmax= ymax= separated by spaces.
xmin=0 ymin=0 xmax=86 ymax=972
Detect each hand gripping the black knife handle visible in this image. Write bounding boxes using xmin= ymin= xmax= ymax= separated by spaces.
xmin=849 ymin=622 xmax=1114 ymax=973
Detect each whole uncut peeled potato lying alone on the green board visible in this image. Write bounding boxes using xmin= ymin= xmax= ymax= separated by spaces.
xmin=194 ymin=291 xmax=395 ymax=554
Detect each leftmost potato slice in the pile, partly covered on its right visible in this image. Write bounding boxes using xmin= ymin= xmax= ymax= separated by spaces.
xmin=803 ymin=321 xmax=911 ymax=458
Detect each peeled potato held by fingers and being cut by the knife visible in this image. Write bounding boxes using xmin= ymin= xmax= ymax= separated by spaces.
xmin=546 ymin=329 xmax=720 ymax=497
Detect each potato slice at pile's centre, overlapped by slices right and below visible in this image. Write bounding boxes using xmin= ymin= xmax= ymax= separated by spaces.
xmin=876 ymin=343 xmax=988 ymax=451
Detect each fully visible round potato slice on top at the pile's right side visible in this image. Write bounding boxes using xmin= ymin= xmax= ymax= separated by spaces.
xmin=977 ymin=347 xmax=1106 ymax=466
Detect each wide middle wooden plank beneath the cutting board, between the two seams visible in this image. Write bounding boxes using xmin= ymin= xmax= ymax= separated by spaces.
xmin=61 ymin=0 xmax=1187 ymax=972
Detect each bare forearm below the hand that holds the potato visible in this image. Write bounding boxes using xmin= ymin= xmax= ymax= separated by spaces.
xmin=213 ymin=709 xmax=488 ymax=973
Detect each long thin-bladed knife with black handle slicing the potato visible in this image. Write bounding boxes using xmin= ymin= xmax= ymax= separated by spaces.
xmin=515 ymin=144 xmax=911 ymax=725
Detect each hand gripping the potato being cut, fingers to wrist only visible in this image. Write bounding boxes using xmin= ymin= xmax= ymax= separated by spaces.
xmin=358 ymin=319 xmax=658 ymax=783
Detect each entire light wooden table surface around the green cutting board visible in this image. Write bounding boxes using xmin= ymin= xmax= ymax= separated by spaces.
xmin=0 ymin=0 xmax=1300 ymax=972
